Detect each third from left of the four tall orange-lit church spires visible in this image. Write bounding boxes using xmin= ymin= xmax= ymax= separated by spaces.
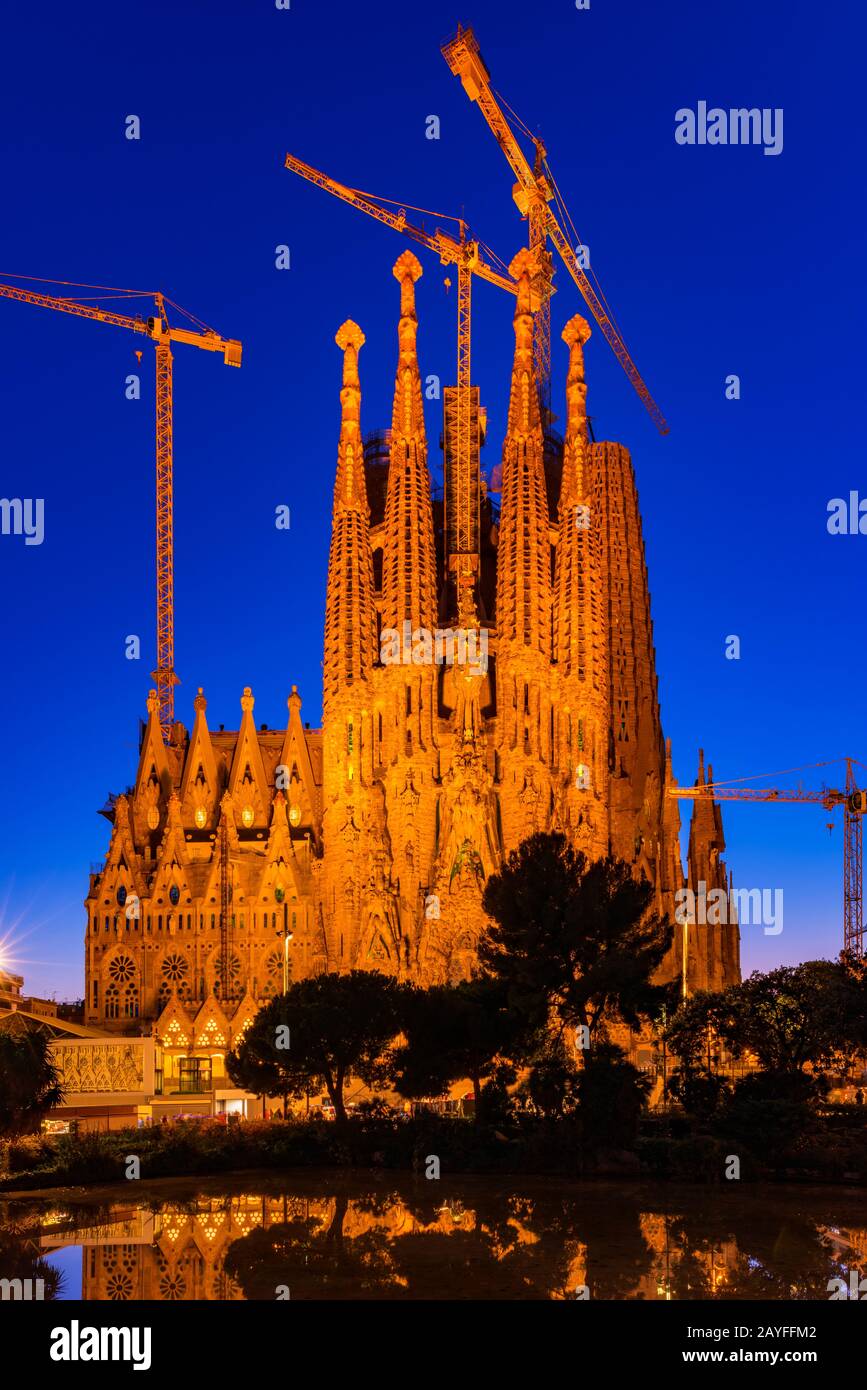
xmin=496 ymin=247 xmax=552 ymax=656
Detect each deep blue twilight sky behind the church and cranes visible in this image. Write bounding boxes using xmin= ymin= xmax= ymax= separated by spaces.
xmin=0 ymin=0 xmax=867 ymax=997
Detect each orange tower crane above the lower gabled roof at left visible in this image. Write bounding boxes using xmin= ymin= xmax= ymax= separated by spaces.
xmin=0 ymin=275 xmax=242 ymax=742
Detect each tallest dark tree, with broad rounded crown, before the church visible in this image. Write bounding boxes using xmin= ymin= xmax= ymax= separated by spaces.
xmin=479 ymin=834 xmax=672 ymax=1040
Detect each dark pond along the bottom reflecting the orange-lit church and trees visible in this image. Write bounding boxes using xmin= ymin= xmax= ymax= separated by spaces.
xmin=0 ymin=1173 xmax=867 ymax=1301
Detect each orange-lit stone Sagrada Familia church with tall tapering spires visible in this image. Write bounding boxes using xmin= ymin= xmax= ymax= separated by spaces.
xmin=85 ymin=250 xmax=739 ymax=1049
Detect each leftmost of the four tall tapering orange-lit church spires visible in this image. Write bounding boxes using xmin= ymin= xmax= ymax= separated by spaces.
xmin=322 ymin=320 xmax=375 ymax=705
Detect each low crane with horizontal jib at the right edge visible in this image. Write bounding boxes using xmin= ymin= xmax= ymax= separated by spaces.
xmin=668 ymin=758 xmax=867 ymax=959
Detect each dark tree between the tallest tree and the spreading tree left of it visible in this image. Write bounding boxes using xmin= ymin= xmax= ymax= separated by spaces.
xmin=395 ymin=980 xmax=521 ymax=1122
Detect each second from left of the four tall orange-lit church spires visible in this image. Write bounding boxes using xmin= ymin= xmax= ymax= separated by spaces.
xmin=382 ymin=250 xmax=436 ymax=639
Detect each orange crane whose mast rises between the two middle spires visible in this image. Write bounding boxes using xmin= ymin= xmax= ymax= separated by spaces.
xmin=286 ymin=154 xmax=517 ymax=616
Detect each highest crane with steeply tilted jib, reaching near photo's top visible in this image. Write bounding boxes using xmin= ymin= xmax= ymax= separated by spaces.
xmin=442 ymin=26 xmax=668 ymax=435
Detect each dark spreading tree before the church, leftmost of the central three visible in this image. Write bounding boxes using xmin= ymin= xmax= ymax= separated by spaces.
xmin=226 ymin=970 xmax=406 ymax=1123
